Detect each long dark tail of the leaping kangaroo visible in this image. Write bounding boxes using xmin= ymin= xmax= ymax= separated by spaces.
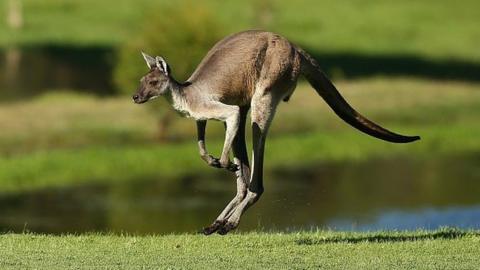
xmin=297 ymin=48 xmax=420 ymax=143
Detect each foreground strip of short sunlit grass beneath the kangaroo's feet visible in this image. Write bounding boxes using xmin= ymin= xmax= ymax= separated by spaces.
xmin=0 ymin=229 xmax=480 ymax=269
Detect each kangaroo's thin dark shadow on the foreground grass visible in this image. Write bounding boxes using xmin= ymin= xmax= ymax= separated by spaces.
xmin=295 ymin=229 xmax=480 ymax=245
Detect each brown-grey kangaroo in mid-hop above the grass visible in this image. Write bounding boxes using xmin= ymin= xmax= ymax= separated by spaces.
xmin=133 ymin=30 xmax=420 ymax=235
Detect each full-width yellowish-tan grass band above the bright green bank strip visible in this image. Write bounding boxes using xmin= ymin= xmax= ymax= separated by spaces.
xmin=0 ymin=78 xmax=480 ymax=155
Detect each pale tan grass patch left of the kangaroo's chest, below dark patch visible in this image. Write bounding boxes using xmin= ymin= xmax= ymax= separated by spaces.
xmin=0 ymin=93 xmax=155 ymax=154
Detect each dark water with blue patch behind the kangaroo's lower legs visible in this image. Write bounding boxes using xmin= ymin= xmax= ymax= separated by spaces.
xmin=0 ymin=154 xmax=480 ymax=234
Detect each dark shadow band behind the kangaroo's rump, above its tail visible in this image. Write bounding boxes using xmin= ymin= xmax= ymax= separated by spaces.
xmin=307 ymin=49 xmax=480 ymax=82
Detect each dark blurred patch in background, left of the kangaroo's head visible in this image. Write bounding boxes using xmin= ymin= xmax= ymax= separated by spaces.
xmin=0 ymin=46 xmax=114 ymax=102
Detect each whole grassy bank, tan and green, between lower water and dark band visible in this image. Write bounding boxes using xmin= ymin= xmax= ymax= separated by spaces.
xmin=0 ymin=79 xmax=480 ymax=192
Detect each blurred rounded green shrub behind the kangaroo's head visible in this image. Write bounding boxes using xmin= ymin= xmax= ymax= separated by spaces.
xmin=114 ymin=2 xmax=224 ymax=140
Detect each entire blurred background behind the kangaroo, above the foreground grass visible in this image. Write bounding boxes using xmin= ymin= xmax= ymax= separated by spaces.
xmin=0 ymin=0 xmax=480 ymax=234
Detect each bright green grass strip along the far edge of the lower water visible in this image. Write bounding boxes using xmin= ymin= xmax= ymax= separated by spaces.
xmin=0 ymin=122 xmax=480 ymax=193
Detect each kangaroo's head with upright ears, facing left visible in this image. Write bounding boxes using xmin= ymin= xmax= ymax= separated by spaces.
xmin=132 ymin=52 xmax=170 ymax=104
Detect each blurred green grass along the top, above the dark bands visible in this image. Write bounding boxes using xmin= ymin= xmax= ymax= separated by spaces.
xmin=0 ymin=0 xmax=480 ymax=61
